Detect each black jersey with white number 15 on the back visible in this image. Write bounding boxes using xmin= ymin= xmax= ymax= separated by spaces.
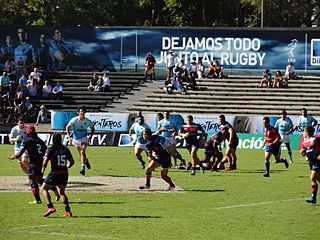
xmin=45 ymin=145 xmax=72 ymax=173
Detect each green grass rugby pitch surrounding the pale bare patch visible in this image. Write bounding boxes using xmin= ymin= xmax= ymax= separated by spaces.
xmin=0 ymin=145 xmax=320 ymax=240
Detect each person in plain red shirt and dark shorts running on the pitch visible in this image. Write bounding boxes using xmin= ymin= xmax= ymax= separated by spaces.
xmin=262 ymin=117 xmax=289 ymax=177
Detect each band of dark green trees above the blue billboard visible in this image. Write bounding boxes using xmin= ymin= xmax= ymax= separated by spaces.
xmin=0 ymin=0 xmax=320 ymax=27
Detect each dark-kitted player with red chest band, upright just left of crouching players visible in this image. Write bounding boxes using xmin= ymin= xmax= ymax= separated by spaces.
xmin=179 ymin=115 xmax=205 ymax=175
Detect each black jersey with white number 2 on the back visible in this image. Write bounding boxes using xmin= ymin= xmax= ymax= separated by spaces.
xmin=22 ymin=136 xmax=47 ymax=168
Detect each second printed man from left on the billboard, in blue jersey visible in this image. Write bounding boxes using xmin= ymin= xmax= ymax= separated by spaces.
xmin=14 ymin=28 xmax=37 ymax=73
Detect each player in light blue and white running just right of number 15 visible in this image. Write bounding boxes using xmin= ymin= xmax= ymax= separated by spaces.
xmin=66 ymin=106 xmax=94 ymax=176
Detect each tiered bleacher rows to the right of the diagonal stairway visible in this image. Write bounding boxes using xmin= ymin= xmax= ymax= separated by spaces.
xmin=128 ymin=75 xmax=320 ymax=115
